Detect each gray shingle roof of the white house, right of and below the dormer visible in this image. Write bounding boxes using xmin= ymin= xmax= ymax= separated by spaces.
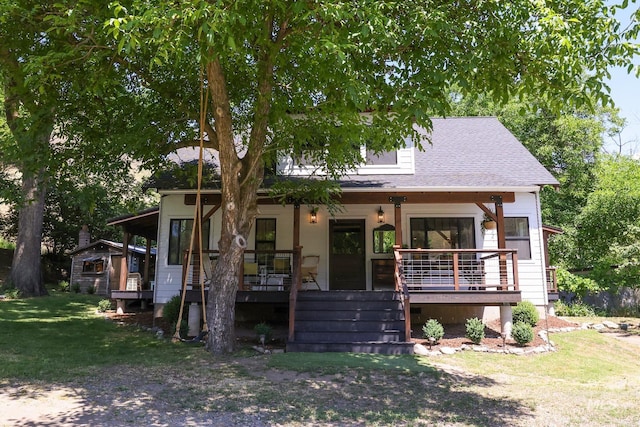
xmin=342 ymin=117 xmax=558 ymax=189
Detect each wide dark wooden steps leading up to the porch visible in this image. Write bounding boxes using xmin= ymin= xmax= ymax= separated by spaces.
xmin=287 ymin=291 xmax=413 ymax=354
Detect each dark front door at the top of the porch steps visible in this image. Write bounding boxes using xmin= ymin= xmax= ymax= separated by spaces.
xmin=329 ymin=219 xmax=367 ymax=290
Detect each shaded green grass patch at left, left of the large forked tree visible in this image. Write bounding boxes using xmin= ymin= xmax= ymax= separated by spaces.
xmin=0 ymin=292 xmax=200 ymax=381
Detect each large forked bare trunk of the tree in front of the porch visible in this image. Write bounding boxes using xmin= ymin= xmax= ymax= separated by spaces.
xmin=207 ymin=56 xmax=268 ymax=354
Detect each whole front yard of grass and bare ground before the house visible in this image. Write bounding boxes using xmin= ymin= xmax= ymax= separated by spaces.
xmin=0 ymin=294 xmax=640 ymax=426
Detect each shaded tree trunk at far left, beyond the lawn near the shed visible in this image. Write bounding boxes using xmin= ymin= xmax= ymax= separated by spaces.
xmin=11 ymin=176 xmax=47 ymax=297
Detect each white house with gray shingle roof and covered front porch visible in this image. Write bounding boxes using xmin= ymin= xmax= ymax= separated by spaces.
xmin=112 ymin=117 xmax=558 ymax=352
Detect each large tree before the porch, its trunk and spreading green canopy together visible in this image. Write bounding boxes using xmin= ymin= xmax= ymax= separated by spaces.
xmin=0 ymin=0 xmax=638 ymax=352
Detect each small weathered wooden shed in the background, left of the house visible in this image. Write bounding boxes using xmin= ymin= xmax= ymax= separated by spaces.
xmin=70 ymin=240 xmax=155 ymax=296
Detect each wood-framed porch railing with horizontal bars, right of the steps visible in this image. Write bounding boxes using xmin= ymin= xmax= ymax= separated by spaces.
xmin=395 ymin=249 xmax=519 ymax=293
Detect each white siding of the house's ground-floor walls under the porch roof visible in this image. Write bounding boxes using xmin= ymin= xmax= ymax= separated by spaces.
xmin=155 ymin=193 xmax=546 ymax=305
